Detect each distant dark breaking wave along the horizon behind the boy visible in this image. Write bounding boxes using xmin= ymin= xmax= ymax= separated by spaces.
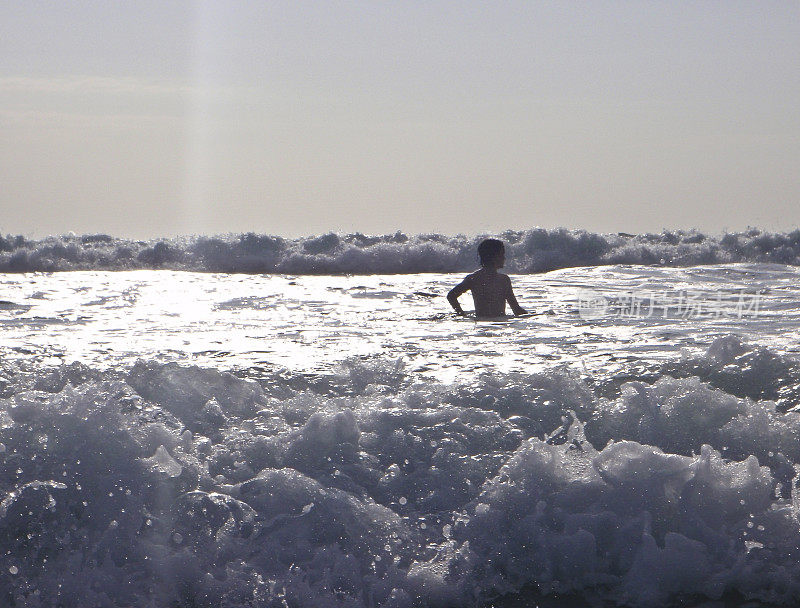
xmin=0 ymin=228 xmax=800 ymax=274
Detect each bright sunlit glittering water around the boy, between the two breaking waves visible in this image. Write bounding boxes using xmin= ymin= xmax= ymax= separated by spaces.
xmin=0 ymin=264 xmax=800 ymax=380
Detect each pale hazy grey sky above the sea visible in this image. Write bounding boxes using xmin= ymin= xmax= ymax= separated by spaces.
xmin=0 ymin=0 xmax=800 ymax=238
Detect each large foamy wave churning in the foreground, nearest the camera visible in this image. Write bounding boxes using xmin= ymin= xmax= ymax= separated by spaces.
xmin=0 ymin=337 xmax=800 ymax=608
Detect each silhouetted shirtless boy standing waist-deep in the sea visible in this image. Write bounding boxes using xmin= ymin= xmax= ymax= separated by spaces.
xmin=447 ymin=239 xmax=526 ymax=317
